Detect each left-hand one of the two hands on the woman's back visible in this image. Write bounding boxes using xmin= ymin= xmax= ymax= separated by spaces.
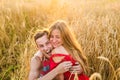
xmin=56 ymin=61 xmax=72 ymax=74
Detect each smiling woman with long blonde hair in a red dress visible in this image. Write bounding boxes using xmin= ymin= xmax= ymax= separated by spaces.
xmin=49 ymin=21 xmax=89 ymax=80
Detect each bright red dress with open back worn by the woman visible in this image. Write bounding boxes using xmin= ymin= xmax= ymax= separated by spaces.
xmin=50 ymin=54 xmax=89 ymax=80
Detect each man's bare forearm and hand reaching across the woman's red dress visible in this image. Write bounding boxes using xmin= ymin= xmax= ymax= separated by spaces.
xmin=38 ymin=61 xmax=72 ymax=80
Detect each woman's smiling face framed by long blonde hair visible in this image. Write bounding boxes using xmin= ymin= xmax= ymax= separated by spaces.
xmin=50 ymin=29 xmax=63 ymax=48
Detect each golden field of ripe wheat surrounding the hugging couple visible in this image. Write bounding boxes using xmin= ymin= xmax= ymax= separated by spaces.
xmin=0 ymin=0 xmax=120 ymax=80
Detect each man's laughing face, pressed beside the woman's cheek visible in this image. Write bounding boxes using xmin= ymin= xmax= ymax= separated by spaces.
xmin=36 ymin=34 xmax=52 ymax=55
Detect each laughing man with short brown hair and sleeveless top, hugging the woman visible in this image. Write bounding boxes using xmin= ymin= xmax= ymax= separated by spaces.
xmin=29 ymin=31 xmax=82 ymax=80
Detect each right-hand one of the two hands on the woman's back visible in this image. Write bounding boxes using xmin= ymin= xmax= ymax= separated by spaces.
xmin=70 ymin=62 xmax=83 ymax=74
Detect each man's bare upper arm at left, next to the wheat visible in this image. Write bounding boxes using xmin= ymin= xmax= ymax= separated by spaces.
xmin=29 ymin=56 xmax=42 ymax=80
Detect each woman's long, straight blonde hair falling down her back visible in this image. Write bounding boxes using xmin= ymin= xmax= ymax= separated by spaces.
xmin=49 ymin=20 xmax=88 ymax=72
